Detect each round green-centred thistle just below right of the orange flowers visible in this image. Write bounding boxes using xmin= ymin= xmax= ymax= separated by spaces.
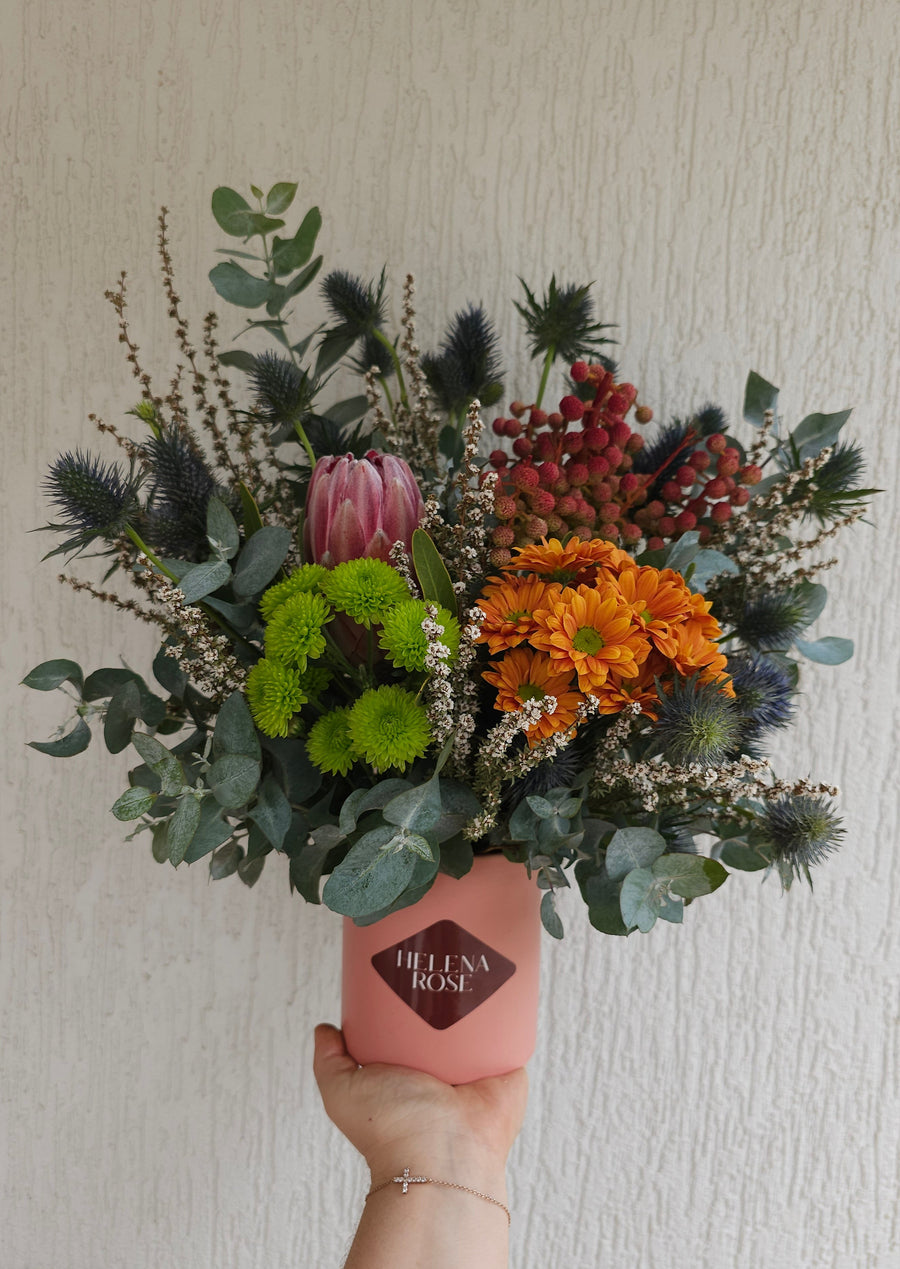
xmin=650 ymin=676 xmax=740 ymax=766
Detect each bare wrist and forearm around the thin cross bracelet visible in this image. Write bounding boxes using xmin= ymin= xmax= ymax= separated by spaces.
xmin=345 ymin=1147 xmax=509 ymax=1269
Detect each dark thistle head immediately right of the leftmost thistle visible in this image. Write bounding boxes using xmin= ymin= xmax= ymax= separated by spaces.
xmin=141 ymin=428 xmax=221 ymax=560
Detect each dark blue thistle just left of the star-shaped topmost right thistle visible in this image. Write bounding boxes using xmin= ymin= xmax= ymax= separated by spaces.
xmin=421 ymin=305 xmax=503 ymax=414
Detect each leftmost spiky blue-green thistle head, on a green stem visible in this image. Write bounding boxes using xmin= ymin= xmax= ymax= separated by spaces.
xmin=43 ymin=449 xmax=140 ymax=552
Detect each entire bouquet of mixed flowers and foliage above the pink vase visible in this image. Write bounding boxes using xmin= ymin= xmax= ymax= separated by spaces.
xmin=24 ymin=183 xmax=875 ymax=937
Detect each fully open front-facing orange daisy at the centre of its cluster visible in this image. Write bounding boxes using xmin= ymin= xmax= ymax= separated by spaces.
xmin=532 ymin=581 xmax=650 ymax=692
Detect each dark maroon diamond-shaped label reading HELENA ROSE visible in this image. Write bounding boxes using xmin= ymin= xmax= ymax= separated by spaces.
xmin=372 ymin=921 xmax=515 ymax=1030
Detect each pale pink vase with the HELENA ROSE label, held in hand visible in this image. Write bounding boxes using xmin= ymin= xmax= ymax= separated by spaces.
xmin=343 ymin=854 xmax=541 ymax=1084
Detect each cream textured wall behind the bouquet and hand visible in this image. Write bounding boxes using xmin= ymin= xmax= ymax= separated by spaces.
xmin=0 ymin=0 xmax=900 ymax=1269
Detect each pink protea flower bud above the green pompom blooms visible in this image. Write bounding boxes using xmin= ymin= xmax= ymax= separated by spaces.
xmin=303 ymin=449 xmax=425 ymax=569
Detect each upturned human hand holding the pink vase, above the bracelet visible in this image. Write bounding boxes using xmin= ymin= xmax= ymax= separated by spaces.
xmin=314 ymin=1024 xmax=528 ymax=1190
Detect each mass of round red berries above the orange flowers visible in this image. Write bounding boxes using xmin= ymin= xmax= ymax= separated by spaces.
xmin=489 ymin=352 xmax=762 ymax=567
